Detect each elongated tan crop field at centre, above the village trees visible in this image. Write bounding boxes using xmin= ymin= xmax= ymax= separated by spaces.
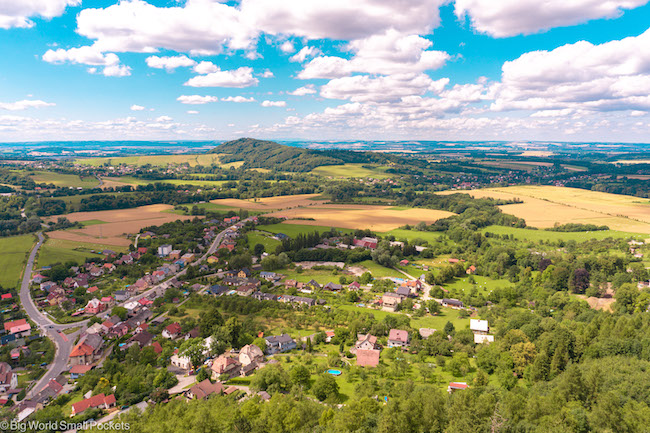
xmin=270 ymin=204 xmax=453 ymax=232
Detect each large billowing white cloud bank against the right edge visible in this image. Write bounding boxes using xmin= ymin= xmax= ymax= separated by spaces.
xmin=492 ymin=29 xmax=650 ymax=111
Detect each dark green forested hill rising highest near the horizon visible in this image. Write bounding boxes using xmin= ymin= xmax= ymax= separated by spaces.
xmin=210 ymin=138 xmax=394 ymax=172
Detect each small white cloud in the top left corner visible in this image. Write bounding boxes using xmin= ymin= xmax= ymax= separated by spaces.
xmin=0 ymin=0 xmax=81 ymax=29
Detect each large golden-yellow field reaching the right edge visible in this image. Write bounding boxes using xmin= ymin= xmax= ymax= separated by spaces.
xmin=440 ymin=186 xmax=650 ymax=234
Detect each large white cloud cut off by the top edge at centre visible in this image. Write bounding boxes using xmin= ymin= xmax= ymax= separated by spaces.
xmin=241 ymin=0 xmax=444 ymax=40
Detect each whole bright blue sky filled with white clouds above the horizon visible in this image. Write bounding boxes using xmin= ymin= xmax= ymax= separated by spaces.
xmin=0 ymin=0 xmax=650 ymax=143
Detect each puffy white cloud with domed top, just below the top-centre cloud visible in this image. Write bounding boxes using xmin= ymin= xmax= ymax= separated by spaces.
xmin=294 ymin=30 xmax=450 ymax=79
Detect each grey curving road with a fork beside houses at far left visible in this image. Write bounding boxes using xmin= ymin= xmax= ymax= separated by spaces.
xmin=20 ymin=232 xmax=88 ymax=397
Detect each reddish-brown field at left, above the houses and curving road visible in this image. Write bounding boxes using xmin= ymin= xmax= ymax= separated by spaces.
xmin=50 ymin=204 xmax=194 ymax=246
